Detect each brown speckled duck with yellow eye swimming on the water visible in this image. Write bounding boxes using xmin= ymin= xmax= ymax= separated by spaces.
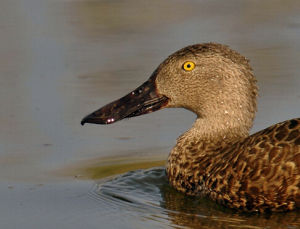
xmin=81 ymin=43 xmax=300 ymax=213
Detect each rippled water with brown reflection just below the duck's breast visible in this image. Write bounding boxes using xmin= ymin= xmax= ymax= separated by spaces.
xmin=89 ymin=167 xmax=300 ymax=228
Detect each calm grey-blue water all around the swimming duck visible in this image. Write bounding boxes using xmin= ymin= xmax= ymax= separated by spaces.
xmin=0 ymin=0 xmax=300 ymax=229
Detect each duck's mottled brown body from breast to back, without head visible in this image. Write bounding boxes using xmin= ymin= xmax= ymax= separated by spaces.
xmin=167 ymin=119 xmax=300 ymax=212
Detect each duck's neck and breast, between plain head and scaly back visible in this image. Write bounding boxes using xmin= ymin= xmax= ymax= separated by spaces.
xmin=166 ymin=118 xmax=252 ymax=194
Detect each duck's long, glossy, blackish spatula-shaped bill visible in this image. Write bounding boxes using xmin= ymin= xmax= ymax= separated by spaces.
xmin=81 ymin=77 xmax=169 ymax=125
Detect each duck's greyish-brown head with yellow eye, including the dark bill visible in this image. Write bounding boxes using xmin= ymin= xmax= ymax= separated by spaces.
xmin=81 ymin=43 xmax=257 ymax=134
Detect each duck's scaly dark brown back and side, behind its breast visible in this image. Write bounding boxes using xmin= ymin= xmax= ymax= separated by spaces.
xmin=205 ymin=119 xmax=300 ymax=211
